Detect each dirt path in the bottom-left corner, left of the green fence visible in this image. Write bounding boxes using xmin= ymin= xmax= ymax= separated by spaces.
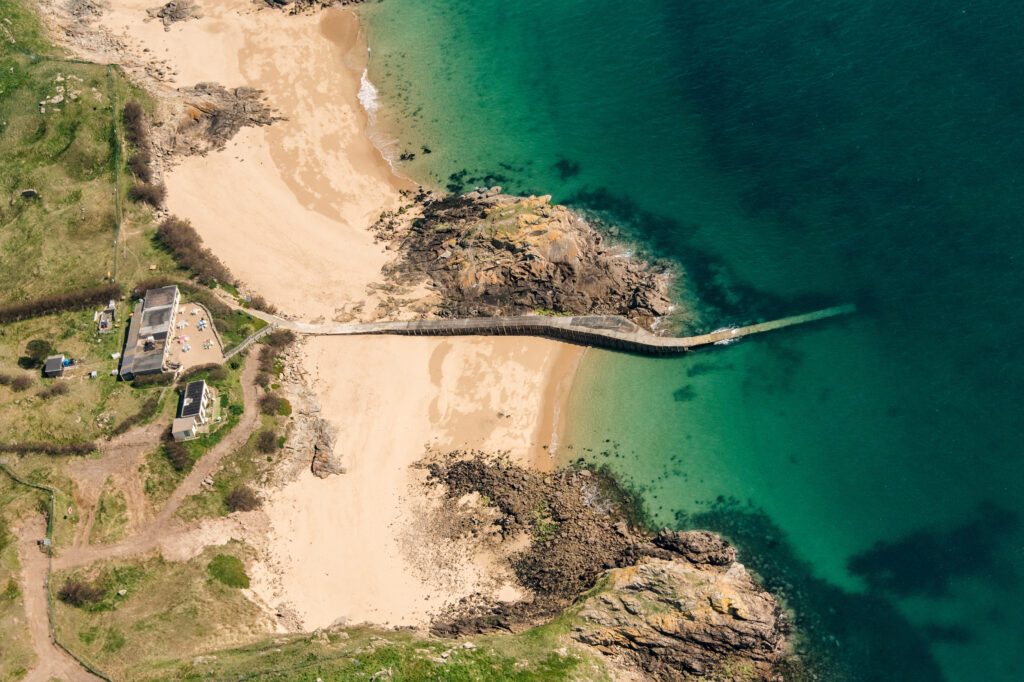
xmin=15 ymin=516 xmax=99 ymax=682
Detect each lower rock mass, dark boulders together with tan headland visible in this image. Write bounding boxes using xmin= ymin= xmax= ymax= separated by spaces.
xmin=426 ymin=453 xmax=791 ymax=680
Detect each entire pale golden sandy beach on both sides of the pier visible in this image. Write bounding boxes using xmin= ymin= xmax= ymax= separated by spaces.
xmin=36 ymin=0 xmax=598 ymax=630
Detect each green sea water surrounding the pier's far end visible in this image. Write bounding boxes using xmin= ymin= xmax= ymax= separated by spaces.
xmin=366 ymin=0 xmax=1024 ymax=680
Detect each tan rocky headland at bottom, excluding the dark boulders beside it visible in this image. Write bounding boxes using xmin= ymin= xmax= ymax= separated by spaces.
xmin=572 ymin=558 xmax=785 ymax=680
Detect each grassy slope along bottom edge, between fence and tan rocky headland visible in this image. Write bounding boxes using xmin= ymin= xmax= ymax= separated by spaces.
xmin=53 ymin=543 xmax=608 ymax=682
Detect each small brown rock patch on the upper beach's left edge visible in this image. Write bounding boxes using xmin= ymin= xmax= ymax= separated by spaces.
xmin=162 ymin=83 xmax=282 ymax=155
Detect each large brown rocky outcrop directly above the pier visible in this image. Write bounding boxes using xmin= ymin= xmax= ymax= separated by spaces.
xmin=374 ymin=187 xmax=672 ymax=329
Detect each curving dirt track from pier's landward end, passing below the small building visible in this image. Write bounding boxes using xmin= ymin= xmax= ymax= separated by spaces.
xmin=53 ymin=359 xmax=259 ymax=570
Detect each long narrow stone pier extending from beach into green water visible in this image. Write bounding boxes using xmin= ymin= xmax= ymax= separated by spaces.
xmin=250 ymin=303 xmax=856 ymax=355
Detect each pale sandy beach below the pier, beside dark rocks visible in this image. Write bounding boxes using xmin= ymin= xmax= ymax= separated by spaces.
xmin=253 ymin=337 xmax=582 ymax=629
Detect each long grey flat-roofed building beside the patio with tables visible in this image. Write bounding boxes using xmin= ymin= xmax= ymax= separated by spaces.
xmin=120 ymin=285 xmax=181 ymax=381
